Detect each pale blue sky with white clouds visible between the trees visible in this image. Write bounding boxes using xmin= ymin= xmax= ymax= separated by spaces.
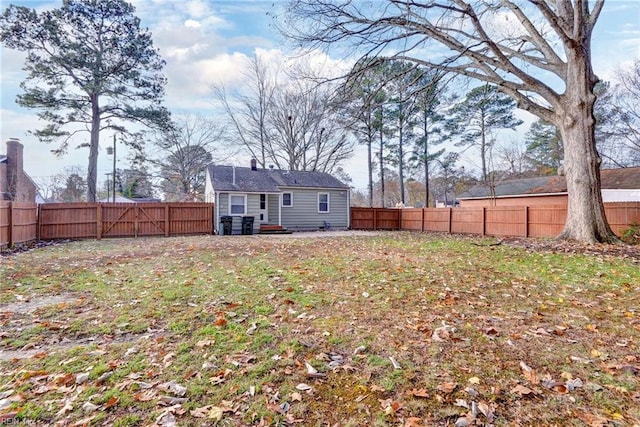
xmin=0 ymin=0 xmax=640 ymax=194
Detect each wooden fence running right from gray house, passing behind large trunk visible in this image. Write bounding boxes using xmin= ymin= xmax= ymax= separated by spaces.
xmin=351 ymin=202 xmax=640 ymax=237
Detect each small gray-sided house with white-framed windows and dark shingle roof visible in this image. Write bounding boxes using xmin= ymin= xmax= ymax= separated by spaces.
xmin=205 ymin=159 xmax=350 ymax=234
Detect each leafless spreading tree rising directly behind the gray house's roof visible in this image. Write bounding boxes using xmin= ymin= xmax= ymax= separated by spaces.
xmin=213 ymin=56 xmax=353 ymax=172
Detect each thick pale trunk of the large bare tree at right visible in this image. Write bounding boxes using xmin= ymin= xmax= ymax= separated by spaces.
xmin=556 ymin=49 xmax=618 ymax=243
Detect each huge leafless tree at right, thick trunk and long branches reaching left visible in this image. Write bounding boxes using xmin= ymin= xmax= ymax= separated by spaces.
xmin=280 ymin=0 xmax=619 ymax=242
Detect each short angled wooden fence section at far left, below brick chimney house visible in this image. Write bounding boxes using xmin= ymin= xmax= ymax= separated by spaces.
xmin=0 ymin=201 xmax=38 ymax=247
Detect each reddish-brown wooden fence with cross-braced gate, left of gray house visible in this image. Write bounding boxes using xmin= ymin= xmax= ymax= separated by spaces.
xmin=38 ymin=203 xmax=213 ymax=240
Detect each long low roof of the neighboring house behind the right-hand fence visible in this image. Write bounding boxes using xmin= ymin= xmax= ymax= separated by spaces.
xmin=458 ymin=167 xmax=640 ymax=199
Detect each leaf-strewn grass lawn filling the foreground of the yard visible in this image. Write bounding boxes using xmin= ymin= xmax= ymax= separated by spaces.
xmin=0 ymin=232 xmax=640 ymax=427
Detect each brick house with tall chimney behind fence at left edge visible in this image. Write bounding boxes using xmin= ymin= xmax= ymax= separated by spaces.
xmin=0 ymin=138 xmax=37 ymax=203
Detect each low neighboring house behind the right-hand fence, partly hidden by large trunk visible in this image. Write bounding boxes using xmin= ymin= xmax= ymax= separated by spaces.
xmin=458 ymin=167 xmax=640 ymax=207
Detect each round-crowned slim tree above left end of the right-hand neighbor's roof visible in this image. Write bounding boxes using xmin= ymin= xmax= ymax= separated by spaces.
xmin=451 ymin=83 xmax=522 ymax=182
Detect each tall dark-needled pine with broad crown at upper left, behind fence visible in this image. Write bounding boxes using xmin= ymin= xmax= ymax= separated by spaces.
xmin=0 ymin=0 xmax=169 ymax=202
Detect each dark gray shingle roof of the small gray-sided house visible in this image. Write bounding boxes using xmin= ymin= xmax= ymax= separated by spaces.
xmin=208 ymin=164 xmax=349 ymax=193
